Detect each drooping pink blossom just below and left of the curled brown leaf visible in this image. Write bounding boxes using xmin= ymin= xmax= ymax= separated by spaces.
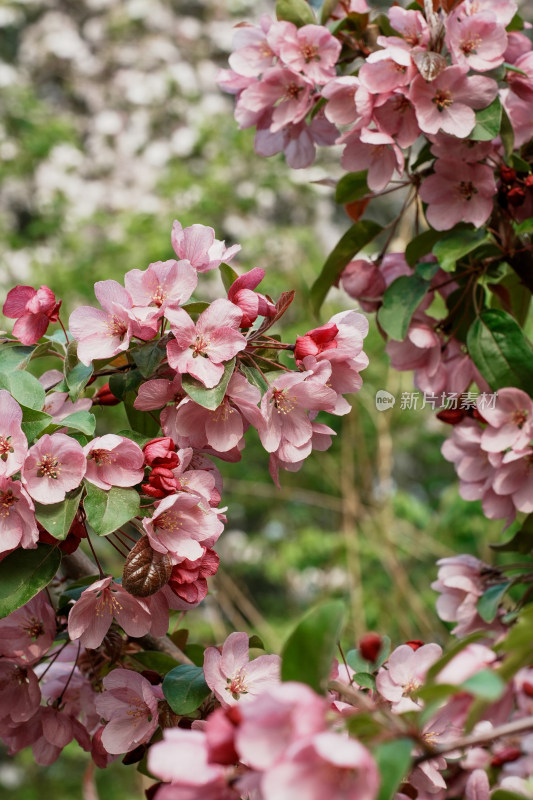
xmin=68 ymin=576 xmax=151 ymax=649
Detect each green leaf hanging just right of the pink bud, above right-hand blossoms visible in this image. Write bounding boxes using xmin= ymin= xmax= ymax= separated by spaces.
xmin=378 ymin=264 xmax=439 ymax=341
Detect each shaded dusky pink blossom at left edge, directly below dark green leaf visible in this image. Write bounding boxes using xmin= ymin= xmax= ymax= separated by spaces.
xmin=0 ymin=592 xmax=56 ymax=665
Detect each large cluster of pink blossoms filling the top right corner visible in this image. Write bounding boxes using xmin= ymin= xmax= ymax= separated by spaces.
xmin=219 ymin=0 xmax=533 ymax=230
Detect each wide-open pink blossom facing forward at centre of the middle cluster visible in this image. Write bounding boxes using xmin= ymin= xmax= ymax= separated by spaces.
xmin=165 ymin=298 xmax=246 ymax=389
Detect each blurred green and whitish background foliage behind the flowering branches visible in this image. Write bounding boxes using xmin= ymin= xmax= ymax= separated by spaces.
xmin=0 ymin=0 xmax=512 ymax=800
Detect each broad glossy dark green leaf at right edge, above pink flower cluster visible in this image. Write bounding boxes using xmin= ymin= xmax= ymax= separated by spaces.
xmin=466 ymin=308 xmax=533 ymax=395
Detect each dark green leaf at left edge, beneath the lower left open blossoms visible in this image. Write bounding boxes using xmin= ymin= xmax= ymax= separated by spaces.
xmin=0 ymin=544 xmax=61 ymax=617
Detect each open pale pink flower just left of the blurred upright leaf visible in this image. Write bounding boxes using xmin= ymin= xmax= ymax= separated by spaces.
xmin=204 ymin=633 xmax=281 ymax=708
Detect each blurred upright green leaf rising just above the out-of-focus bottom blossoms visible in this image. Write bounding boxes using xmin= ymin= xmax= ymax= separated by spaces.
xmin=281 ymin=600 xmax=344 ymax=694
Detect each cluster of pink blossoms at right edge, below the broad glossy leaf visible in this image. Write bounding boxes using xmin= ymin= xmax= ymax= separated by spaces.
xmin=442 ymin=387 xmax=533 ymax=525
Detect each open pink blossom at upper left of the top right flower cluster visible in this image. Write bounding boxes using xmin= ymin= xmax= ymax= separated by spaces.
xmin=267 ymin=22 xmax=341 ymax=84
